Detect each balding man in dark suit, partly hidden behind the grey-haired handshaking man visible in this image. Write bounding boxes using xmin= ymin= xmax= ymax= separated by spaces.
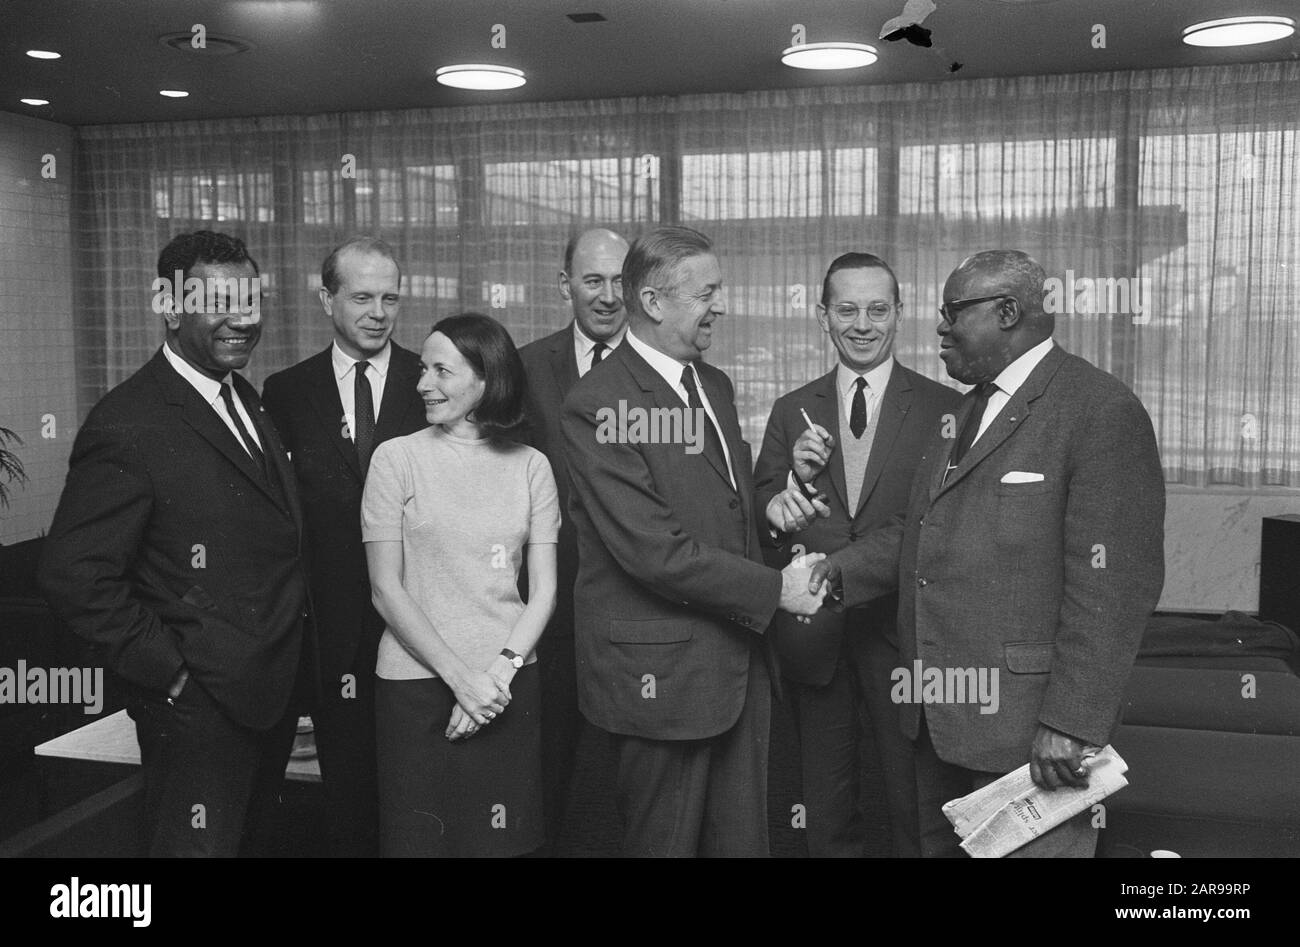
xmin=519 ymin=229 xmax=628 ymax=846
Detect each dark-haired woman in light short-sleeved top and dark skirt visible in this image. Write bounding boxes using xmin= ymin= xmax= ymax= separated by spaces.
xmin=361 ymin=312 xmax=560 ymax=856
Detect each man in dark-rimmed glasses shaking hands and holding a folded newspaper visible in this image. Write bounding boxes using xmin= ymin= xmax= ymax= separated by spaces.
xmin=813 ymin=251 xmax=1165 ymax=857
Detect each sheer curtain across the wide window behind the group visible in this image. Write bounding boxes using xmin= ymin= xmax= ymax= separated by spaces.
xmin=77 ymin=62 xmax=1300 ymax=487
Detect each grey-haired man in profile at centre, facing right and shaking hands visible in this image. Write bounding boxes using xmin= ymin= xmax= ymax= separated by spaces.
xmin=560 ymin=226 xmax=820 ymax=856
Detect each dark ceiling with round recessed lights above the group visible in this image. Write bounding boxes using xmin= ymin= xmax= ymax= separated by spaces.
xmin=0 ymin=0 xmax=1300 ymax=125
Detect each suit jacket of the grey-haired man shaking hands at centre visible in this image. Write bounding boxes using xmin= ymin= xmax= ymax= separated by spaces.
xmin=560 ymin=342 xmax=781 ymax=740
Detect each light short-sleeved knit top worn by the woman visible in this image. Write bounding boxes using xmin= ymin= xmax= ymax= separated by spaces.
xmin=361 ymin=425 xmax=560 ymax=680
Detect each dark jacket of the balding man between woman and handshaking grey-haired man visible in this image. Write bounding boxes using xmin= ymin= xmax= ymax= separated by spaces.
xmin=519 ymin=323 xmax=577 ymax=637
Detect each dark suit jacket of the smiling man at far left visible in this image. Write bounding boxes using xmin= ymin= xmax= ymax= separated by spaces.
xmin=40 ymin=350 xmax=308 ymax=728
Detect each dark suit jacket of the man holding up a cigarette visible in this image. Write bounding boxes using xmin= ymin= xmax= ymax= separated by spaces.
xmin=754 ymin=363 xmax=962 ymax=687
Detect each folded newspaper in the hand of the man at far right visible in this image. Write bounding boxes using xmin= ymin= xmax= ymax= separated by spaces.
xmin=944 ymin=745 xmax=1128 ymax=859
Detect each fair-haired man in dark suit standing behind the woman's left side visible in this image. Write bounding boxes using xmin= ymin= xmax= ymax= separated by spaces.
xmin=263 ymin=237 xmax=425 ymax=857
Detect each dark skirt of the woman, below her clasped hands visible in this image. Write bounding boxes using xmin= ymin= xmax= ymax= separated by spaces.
xmin=374 ymin=665 xmax=545 ymax=859
